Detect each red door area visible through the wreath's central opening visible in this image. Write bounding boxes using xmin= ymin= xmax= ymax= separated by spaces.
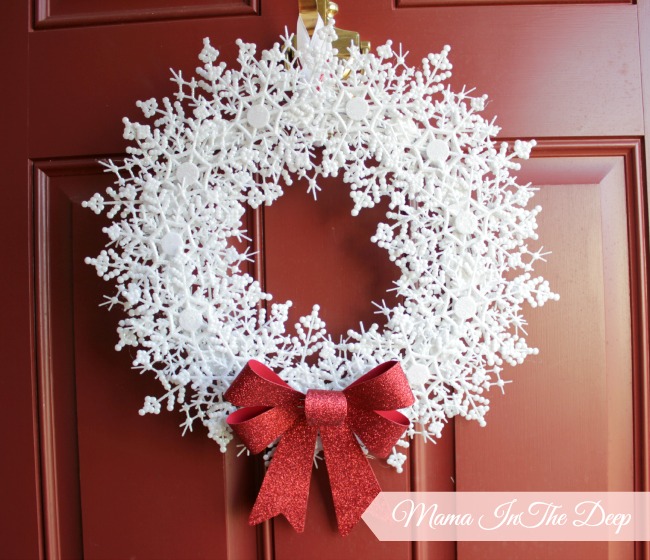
xmin=264 ymin=172 xmax=400 ymax=346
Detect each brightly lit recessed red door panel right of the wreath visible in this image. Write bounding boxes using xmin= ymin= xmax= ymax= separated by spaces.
xmin=456 ymin=142 xmax=644 ymax=560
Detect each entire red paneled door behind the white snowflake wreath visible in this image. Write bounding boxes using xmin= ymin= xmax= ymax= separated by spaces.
xmin=0 ymin=0 xmax=650 ymax=560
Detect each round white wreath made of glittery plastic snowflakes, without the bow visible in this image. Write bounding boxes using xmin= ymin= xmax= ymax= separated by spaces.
xmin=85 ymin=21 xmax=557 ymax=471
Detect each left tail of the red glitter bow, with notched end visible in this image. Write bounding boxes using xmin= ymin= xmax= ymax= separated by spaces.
xmin=248 ymin=421 xmax=317 ymax=533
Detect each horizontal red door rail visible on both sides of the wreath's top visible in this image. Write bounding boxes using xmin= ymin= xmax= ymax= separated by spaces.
xmin=30 ymin=4 xmax=643 ymax=158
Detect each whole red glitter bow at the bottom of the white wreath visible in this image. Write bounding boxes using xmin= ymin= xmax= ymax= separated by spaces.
xmin=224 ymin=360 xmax=414 ymax=535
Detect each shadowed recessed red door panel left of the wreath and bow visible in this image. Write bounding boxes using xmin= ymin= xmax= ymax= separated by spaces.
xmin=35 ymin=159 xmax=259 ymax=559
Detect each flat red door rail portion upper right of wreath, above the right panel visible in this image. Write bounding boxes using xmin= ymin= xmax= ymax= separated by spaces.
xmin=382 ymin=5 xmax=643 ymax=138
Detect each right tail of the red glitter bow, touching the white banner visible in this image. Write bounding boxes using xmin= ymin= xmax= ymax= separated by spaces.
xmin=320 ymin=423 xmax=381 ymax=536
